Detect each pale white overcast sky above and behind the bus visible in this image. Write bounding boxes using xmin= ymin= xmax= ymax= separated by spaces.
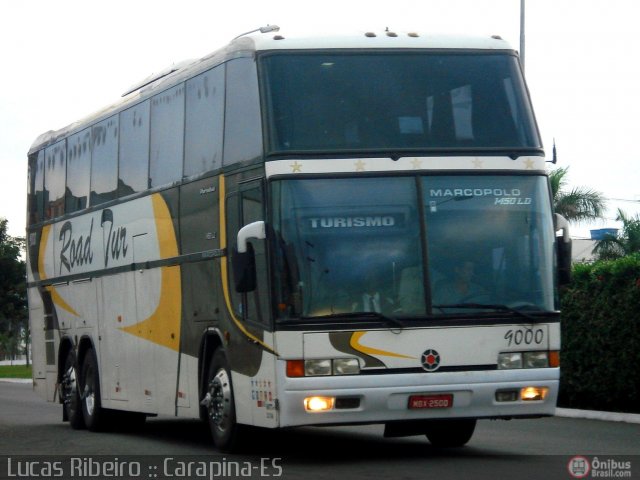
xmin=0 ymin=0 xmax=640 ymax=237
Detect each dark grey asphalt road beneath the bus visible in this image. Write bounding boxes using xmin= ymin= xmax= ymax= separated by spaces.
xmin=0 ymin=382 xmax=640 ymax=480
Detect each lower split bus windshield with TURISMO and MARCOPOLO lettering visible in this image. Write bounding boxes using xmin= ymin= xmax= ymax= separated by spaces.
xmin=272 ymin=175 xmax=554 ymax=320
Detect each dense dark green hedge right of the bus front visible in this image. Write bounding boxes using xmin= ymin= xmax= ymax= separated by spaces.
xmin=559 ymin=253 xmax=640 ymax=413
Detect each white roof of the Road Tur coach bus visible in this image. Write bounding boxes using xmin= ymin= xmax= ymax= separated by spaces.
xmin=29 ymin=26 xmax=513 ymax=154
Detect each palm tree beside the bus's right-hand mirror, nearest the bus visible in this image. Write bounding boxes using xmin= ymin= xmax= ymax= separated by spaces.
xmin=549 ymin=167 xmax=606 ymax=222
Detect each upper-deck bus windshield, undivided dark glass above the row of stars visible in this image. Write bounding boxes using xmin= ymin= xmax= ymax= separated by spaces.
xmin=262 ymin=50 xmax=541 ymax=154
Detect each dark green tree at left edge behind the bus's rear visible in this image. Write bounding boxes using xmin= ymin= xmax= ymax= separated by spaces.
xmin=0 ymin=218 xmax=28 ymax=355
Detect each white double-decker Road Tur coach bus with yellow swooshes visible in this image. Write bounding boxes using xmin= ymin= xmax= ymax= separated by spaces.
xmin=27 ymin=27 xmax=570 ymax=450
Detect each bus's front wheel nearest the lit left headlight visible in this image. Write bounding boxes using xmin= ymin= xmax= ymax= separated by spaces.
xmin=202 ymin=349 xmax=245 ymax=453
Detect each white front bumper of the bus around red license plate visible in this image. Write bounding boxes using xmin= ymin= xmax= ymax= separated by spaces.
xmin=278 ymin=362 xmax=560 ymax=427
